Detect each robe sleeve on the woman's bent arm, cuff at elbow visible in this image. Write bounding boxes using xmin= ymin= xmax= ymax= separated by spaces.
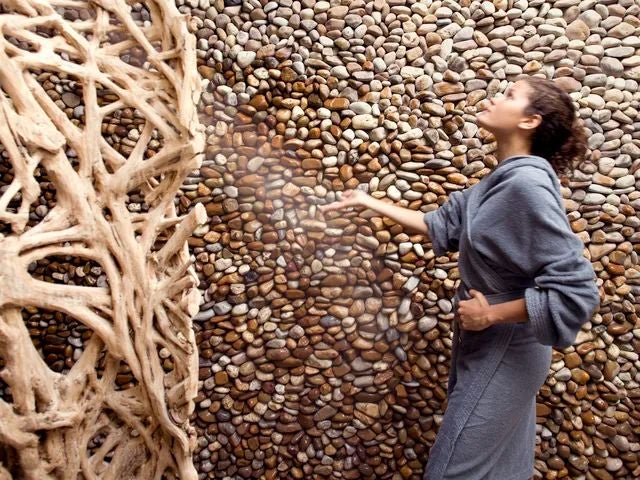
xmin=478 ymin=169 xmax=600 ymax=348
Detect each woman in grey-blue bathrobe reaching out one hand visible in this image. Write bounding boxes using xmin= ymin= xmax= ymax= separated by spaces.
xmin=321 ymin=77 xmax=599 ymax=480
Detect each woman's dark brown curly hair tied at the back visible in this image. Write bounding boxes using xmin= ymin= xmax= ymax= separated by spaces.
xmin=521 ymin=76 xmax=587 ymax=174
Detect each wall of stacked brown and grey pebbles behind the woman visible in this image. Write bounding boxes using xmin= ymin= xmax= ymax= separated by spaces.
xmin=0 ymin=0 xmax=640 ymax=480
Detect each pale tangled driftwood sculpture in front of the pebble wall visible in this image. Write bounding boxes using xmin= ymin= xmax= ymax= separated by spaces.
xmin=0 ymin=0 xmax=206 ymax=480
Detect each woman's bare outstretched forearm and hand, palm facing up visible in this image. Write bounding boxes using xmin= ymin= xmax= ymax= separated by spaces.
xmin=319 ymin=190 xmax=429 ymax=238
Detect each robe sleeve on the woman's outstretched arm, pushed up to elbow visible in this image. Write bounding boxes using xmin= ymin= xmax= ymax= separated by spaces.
xmin=424 ymin=190 xmax=468 ymax=256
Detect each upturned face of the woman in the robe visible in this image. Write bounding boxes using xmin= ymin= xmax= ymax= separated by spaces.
xmin=476 ymin=80 xmax=535 ymax=136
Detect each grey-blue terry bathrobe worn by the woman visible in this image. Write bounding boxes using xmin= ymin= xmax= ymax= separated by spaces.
xmin=424 ymin=156 xmax=599 ymax=480
